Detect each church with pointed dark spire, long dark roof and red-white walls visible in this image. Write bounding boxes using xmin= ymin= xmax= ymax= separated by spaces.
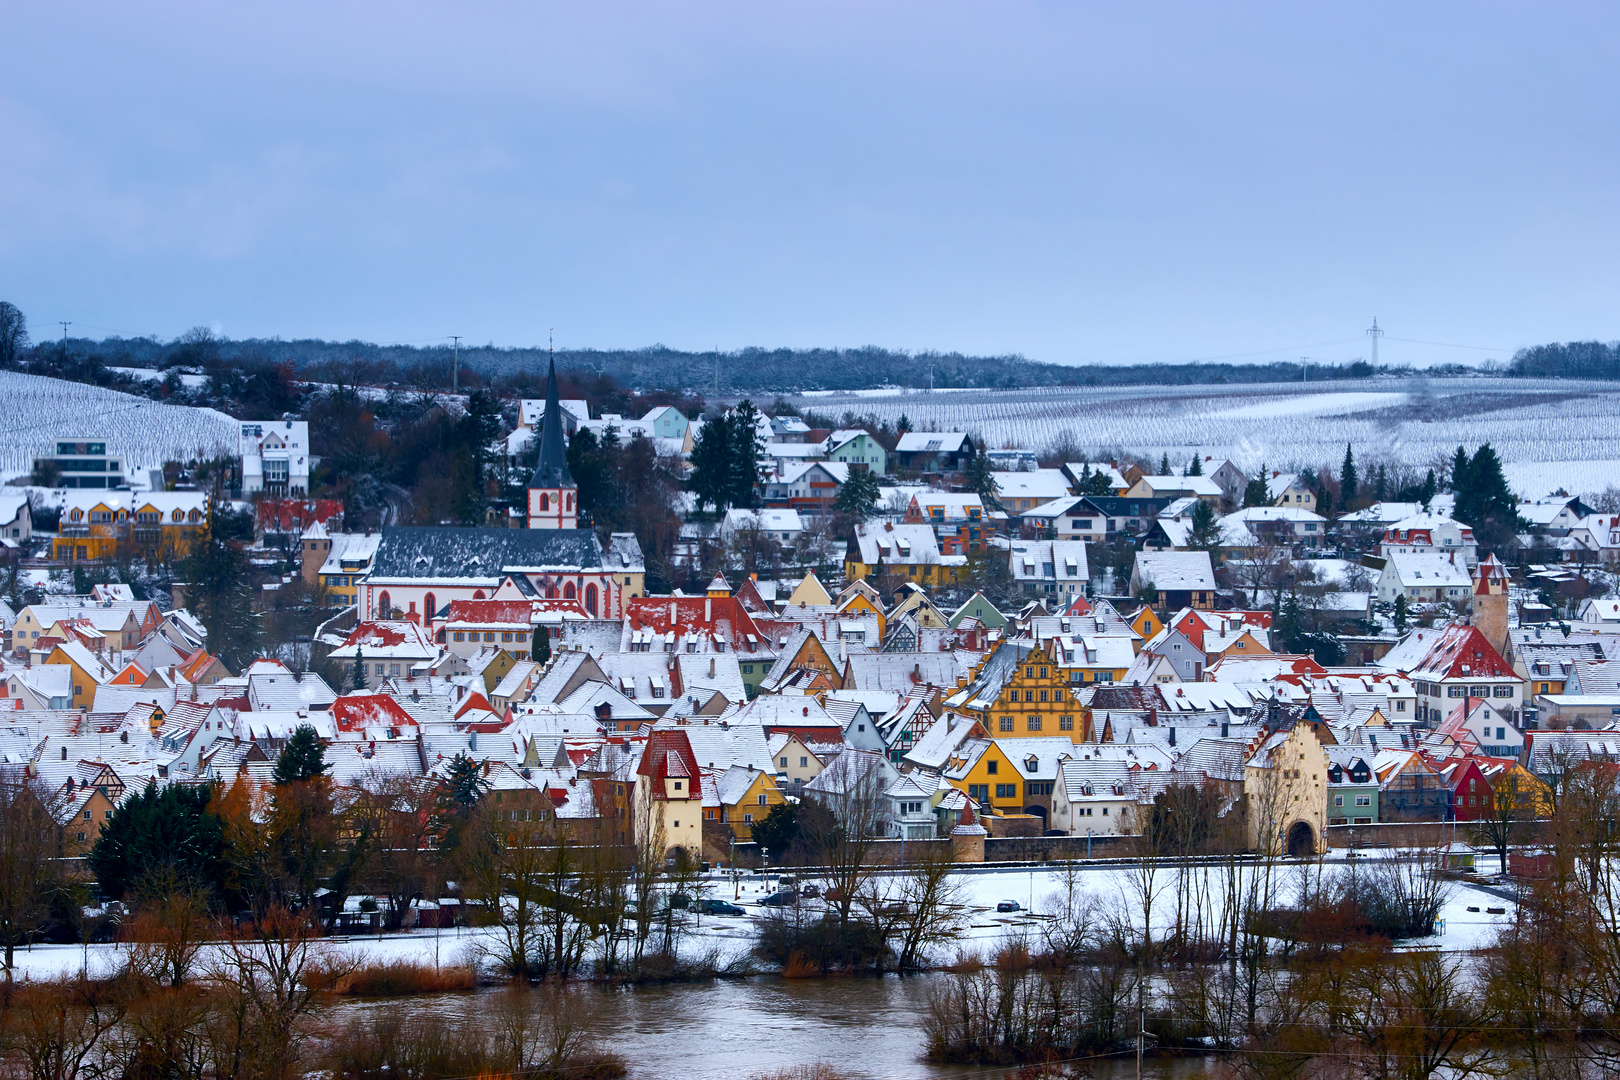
xmin=360 ymin=363 xmax=646 ymax=628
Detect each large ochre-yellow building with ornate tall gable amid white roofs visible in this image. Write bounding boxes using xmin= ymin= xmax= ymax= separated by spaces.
xmin=944 ymin=641 xmax=1092 ymax=743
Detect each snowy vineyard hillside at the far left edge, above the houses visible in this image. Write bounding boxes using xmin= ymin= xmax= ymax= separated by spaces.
xmin=0 ymin=371 xmax=237 ymax=481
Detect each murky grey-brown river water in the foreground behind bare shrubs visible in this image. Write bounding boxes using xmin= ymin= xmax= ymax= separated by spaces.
xmin=339 ymin=975 xmax=1213 ymax=1080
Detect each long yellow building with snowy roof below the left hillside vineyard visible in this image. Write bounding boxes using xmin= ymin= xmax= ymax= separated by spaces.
xmin=50 ymin=491 xmax=209 ymax=562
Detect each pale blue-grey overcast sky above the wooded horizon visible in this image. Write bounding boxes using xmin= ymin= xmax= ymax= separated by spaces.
xmin=0 ymin=0 xmax=1620 ymax=364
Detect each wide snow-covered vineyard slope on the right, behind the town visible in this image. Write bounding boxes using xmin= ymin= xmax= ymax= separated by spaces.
xmin=795 ymin=379 xmax=1620 ymax=497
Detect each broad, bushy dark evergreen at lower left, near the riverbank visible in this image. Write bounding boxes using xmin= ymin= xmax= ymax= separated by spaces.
xmin=86 ymin=780 xmax=225 ymax=900
